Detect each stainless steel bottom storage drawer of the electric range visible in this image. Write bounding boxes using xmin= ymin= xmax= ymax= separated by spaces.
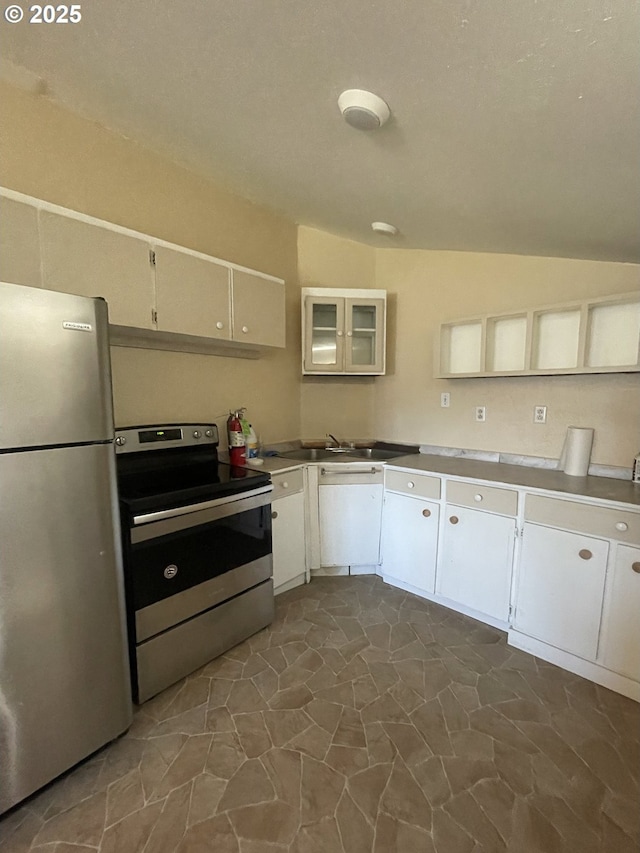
xmin=136 ymin=580 xmax=274 ymax=702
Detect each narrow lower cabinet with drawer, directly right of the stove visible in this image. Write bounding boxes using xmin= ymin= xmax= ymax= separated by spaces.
xmin=271 ymin=469 xmax=306 ymax=594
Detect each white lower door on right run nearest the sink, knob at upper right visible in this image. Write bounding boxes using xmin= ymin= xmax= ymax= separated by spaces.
xmin=382 ymin=492 xmax=440 ymax=594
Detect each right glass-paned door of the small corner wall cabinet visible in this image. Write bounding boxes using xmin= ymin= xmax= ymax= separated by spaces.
xmin=345 ymin=299 xmax=384 ymax=373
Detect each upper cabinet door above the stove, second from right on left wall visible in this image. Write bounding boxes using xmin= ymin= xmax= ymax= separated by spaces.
xmin=155 ymin=246 xmax=231 ymax=340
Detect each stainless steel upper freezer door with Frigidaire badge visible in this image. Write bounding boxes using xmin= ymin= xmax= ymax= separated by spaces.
xmin=0 ymin=282 xmax=113 ymax=451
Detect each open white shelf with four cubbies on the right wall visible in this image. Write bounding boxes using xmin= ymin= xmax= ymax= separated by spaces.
xmin=436 ymin=293 xmax=640 ymax=379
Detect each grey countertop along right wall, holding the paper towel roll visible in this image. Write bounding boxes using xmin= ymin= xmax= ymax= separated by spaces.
xmin=386 ymin=453 xmax=640 ymax=506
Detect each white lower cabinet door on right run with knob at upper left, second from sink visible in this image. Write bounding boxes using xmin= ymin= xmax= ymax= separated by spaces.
xmin=436 ymin=504 xmax=516 ymax=622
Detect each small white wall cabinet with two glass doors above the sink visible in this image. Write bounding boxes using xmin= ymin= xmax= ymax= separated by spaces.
xmin=302 ymin=287 xmax=387 ymax=375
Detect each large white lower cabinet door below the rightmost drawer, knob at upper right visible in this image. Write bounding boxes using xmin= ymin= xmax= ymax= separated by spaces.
xmin=514 ymin=522 xmax=609 ymax=660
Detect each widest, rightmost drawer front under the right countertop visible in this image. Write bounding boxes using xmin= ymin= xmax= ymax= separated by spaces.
xmin=524 ymin=495 xmax=640 ymax=545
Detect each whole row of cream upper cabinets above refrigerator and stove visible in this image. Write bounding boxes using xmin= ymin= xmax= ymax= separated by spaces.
xmin=0 ymin=190 xmax=285 ymax=358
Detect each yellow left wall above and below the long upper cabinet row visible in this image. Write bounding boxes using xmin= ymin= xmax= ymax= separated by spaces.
xmin=0 ymin=84 xmax=300 ymax=441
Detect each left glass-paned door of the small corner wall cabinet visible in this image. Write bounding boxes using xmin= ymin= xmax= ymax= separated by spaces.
xmin=305 ymin=297 xmax=344 ymax=373
